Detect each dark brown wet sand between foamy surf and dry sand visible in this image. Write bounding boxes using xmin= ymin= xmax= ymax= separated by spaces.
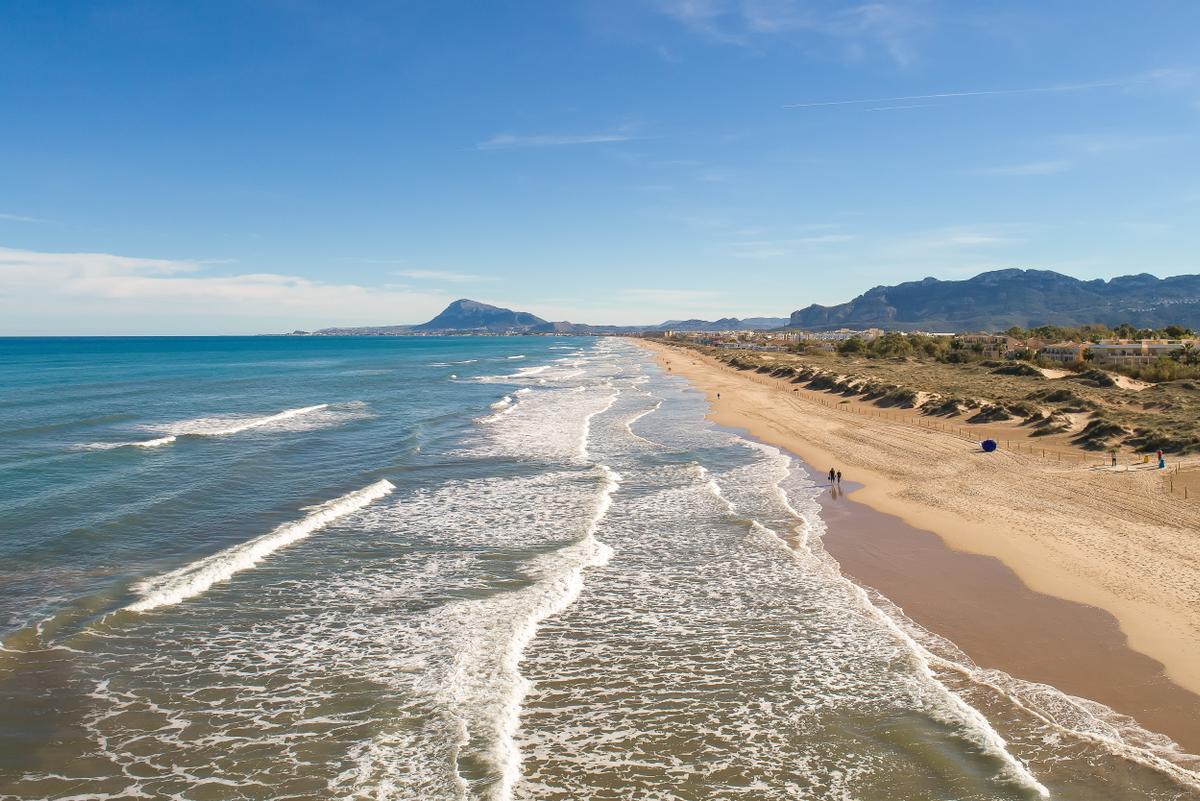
xmin=815 ymin=476 xmax=1200 ymax=753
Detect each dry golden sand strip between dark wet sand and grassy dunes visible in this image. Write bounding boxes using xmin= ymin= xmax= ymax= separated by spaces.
xmin=644 ymin=342 xmax=1200 ymax=692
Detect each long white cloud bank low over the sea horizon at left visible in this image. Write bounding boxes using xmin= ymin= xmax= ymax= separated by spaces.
xmin=0 ymin=248 xmax=451 ymax=333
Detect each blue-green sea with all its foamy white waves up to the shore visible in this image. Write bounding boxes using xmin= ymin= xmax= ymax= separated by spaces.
xmin=0 ymin=337 xmax=1200 ymax=801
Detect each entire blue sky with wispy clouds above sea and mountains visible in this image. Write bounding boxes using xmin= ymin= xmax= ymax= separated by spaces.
xmin=0 ymin=0 xmax=1200 ymax=336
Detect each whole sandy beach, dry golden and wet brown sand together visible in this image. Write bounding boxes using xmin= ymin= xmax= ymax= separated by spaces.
xmin=643 ymin=341 xmax=1200 ymax=752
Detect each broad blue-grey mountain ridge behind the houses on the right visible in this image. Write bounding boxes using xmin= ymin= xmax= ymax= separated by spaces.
xmin=788 ymin=270 xmax=1200 ymax=331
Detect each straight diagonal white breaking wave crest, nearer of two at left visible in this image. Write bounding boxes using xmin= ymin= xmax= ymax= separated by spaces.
xmin=125 ymin=478 xmax=396 ymax=612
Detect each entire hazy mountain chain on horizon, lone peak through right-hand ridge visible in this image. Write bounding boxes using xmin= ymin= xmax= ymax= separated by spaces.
xmin=296 ymin=270 xmax=1200 ymax=336
